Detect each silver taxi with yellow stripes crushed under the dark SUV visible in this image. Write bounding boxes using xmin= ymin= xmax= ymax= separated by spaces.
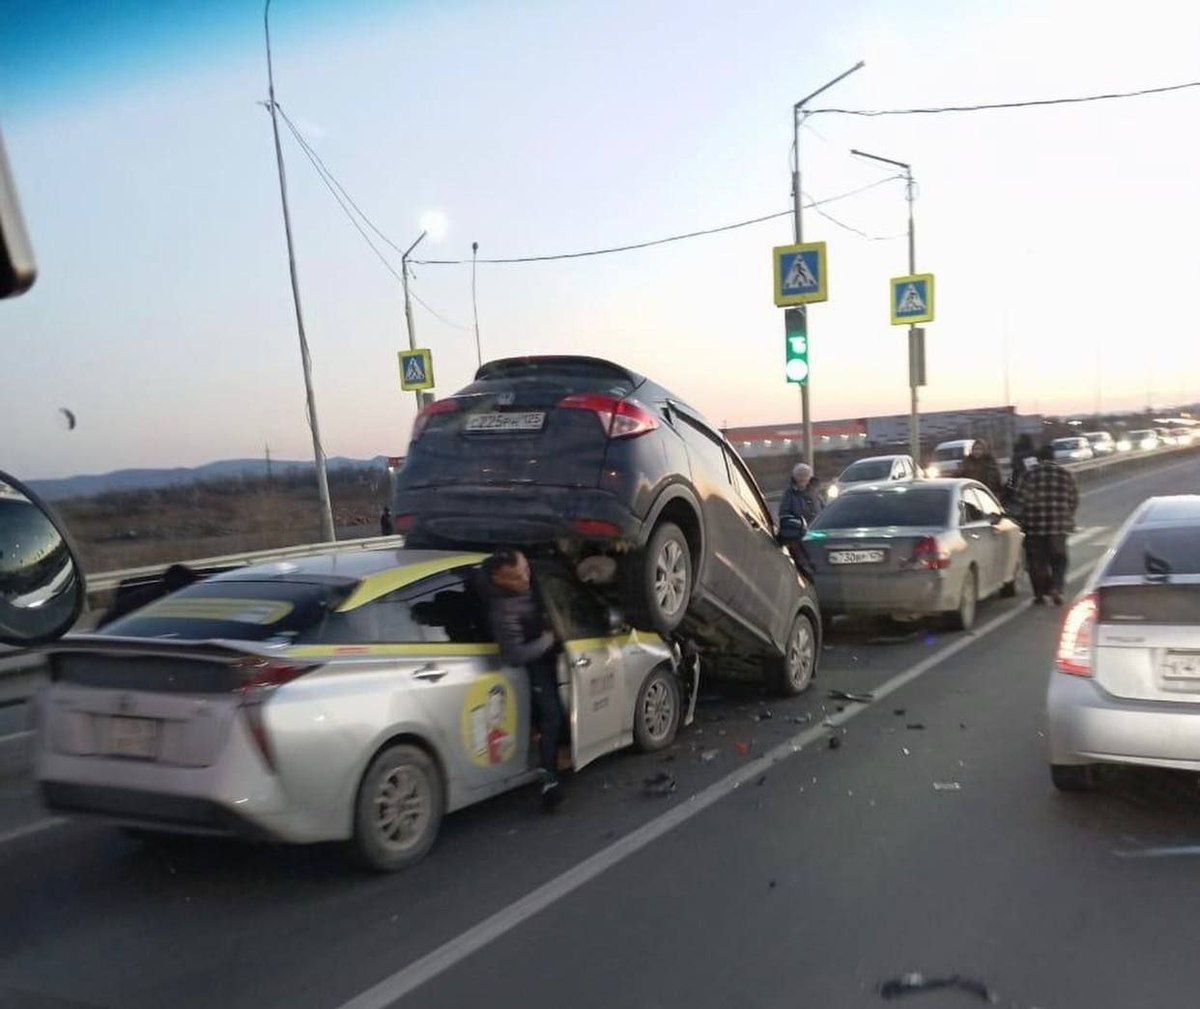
xmin=36 ymin=549 xmax=698 ymax=870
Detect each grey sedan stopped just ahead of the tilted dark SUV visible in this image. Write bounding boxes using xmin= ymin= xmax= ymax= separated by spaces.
xmin=804 ymin=479 xmax=1025 ymax=630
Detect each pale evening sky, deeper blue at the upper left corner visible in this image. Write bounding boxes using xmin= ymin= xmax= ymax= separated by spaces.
xmin=0 ymin=0 xmax=1200 ymax=478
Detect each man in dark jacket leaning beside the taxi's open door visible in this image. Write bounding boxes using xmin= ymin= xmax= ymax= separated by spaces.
xmin=484 ymin=549 xmax=563 ymax=811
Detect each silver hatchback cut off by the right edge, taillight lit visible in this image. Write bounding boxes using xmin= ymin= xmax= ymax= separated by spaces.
xmin=1046 ymin=494 xmax=1200 ymax=792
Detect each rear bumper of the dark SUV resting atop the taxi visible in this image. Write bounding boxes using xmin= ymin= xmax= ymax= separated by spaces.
xmin=392 ymin=485 xmax=643 ymax=546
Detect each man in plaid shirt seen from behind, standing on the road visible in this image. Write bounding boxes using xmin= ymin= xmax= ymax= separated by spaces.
xmin=1018 ymin=445 xmax=1079 ymax=606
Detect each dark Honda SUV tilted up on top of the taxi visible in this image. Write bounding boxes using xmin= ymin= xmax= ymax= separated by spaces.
xmin=392 ymin=356 xmax=821 ymax=692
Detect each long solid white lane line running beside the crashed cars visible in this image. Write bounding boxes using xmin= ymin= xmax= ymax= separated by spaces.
xmin=338 ymin=539 xmax=1104 ymax=1009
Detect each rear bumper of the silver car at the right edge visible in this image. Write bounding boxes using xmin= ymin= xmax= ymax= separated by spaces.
xmin=1046 ymin=672 xmax=1200 ymax=770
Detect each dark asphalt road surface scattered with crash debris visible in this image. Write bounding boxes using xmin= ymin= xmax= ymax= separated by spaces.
xmin=0 ymin=462 xmax=1200 ymax=1009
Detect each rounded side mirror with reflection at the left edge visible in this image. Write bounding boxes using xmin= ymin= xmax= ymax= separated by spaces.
xmin=0 ymin=473 xmax=86 ymax=647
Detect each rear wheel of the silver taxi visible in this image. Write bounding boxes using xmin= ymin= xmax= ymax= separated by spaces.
xmin=352 ymin=744 xmax=445 ymax=872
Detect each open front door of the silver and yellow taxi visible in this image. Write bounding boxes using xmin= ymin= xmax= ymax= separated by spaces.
xmin=535 ymin=566 xmax=631 ymax=770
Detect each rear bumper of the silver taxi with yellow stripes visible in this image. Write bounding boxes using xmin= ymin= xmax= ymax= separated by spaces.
xmin=37 ymin=715 xmax=349 ymax=843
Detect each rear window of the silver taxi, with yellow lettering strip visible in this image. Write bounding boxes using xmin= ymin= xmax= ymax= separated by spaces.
xmin=100 ymin=581 xmax=354 ymax=641
